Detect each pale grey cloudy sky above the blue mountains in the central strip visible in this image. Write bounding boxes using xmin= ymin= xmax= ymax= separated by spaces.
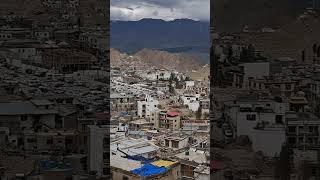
xmin=110 ymin=0 xmax=210 ymax=21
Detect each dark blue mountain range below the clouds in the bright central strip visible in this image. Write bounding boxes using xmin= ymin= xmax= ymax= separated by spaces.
xmin=110 ymin=19 xmax=210 ymax=63
